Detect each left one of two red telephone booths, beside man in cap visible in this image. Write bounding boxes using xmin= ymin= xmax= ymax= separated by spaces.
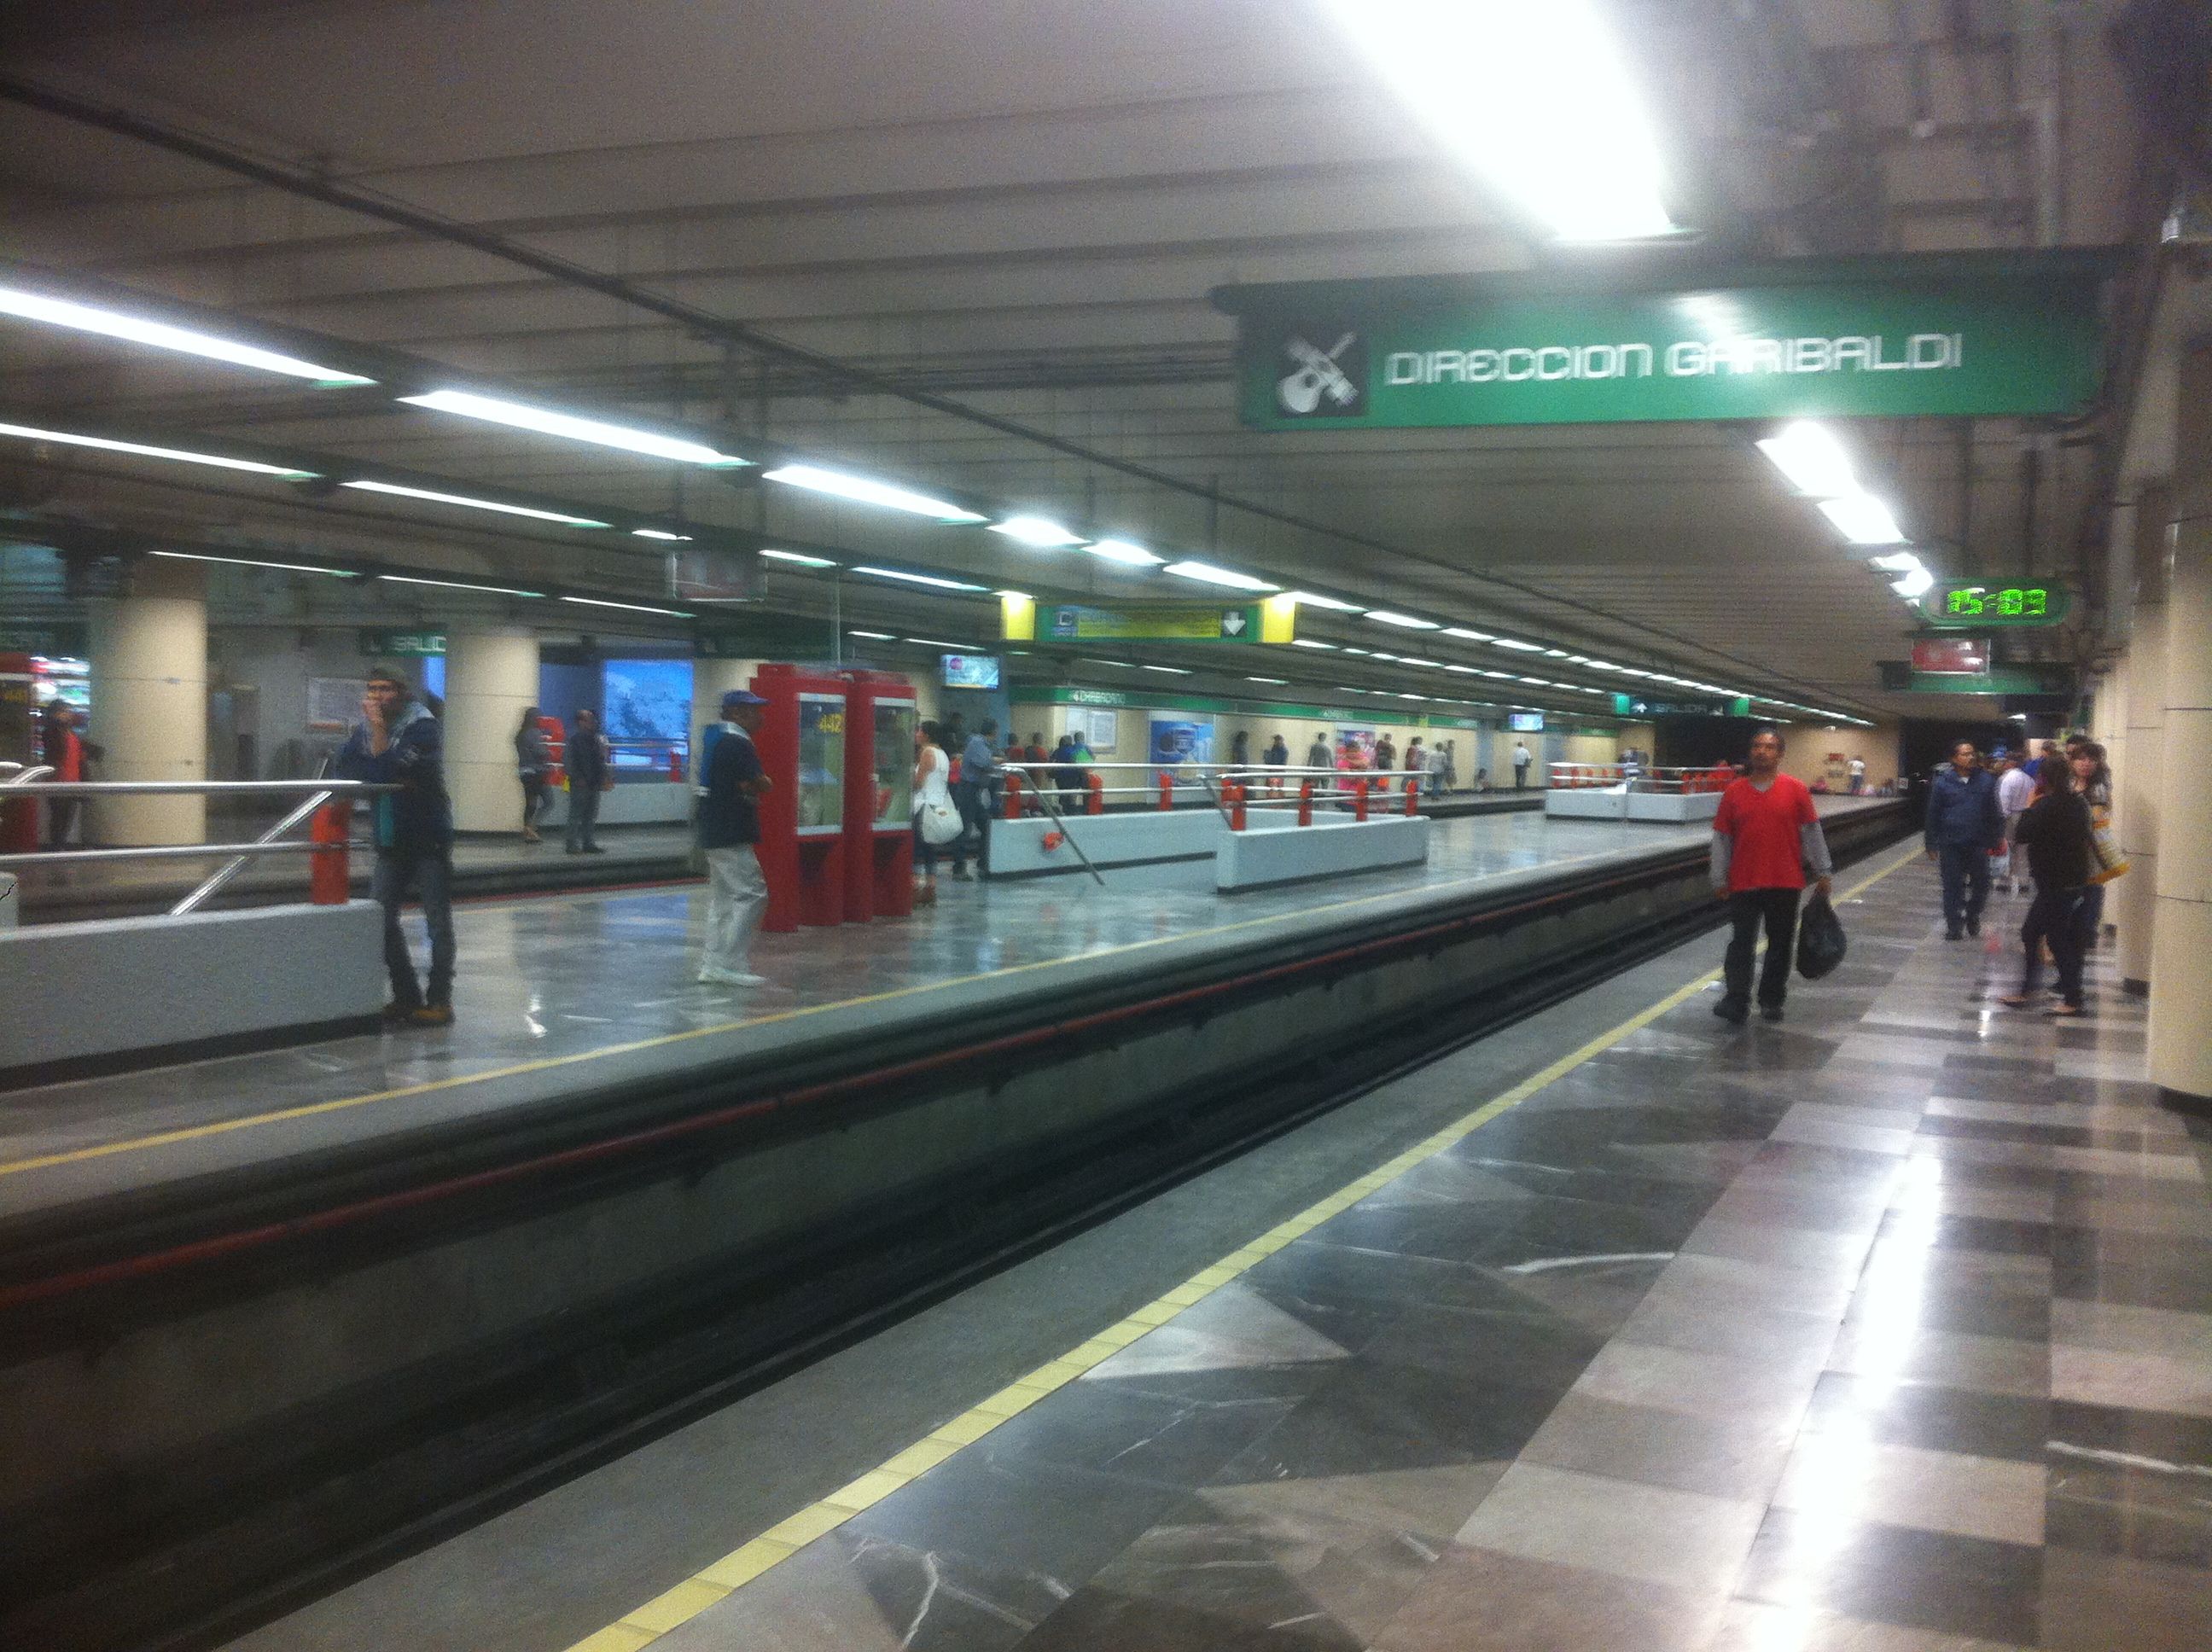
xmin=750 ymin=661 xmax=849 ymax=934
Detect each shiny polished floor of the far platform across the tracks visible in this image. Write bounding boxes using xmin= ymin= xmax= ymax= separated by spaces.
xmin=0 ymin=799 xmax=1865 ymax=1185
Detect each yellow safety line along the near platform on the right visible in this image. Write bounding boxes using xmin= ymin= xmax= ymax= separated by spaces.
xmin=568 ymin=842 xmax=1920 ymax=1652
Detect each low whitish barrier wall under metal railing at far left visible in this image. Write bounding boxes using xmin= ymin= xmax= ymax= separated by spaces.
xmin=0 ymin=900 xmax=385 ymax=1070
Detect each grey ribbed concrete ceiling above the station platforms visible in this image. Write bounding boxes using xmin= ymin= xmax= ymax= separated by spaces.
xmin=0 ymin=0 xmax=2176 ymax=714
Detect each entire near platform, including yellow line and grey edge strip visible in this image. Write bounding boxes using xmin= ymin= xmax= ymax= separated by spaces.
xmin=219 ymin=847 xmax=2212 ymax=1652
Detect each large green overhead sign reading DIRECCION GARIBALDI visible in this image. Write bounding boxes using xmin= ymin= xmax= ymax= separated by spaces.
xmin=1217 ymin=252 xmax=2108 ymax=431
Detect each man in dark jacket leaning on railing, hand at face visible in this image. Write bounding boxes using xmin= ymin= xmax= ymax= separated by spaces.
xmin=334 ymin=668 xmax=453 ymax=1027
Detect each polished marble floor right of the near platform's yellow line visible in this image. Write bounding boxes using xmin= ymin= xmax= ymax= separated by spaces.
xmin=526 ymin=860 xmax=2212 ymax=1652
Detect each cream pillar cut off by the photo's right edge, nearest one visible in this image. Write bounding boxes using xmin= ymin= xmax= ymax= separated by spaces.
xmin=2158 ymin=345 xmax=2212 ymax=1099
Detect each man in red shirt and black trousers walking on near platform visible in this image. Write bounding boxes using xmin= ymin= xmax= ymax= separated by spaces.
xmin=1712 ymin=728 xmax=1834 ymax=1027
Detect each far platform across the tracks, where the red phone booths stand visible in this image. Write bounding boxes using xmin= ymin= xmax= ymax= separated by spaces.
xmin=0 ymin=794 xmax=1887 ymax=1216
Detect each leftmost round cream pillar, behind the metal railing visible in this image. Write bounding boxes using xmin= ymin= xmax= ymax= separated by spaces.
xmin=84 ymin=557 xmax=208 ymax=847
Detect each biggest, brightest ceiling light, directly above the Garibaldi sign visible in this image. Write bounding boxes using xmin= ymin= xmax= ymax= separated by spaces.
xmin=1327 ymin=0 xmax=1674 ymax=241
